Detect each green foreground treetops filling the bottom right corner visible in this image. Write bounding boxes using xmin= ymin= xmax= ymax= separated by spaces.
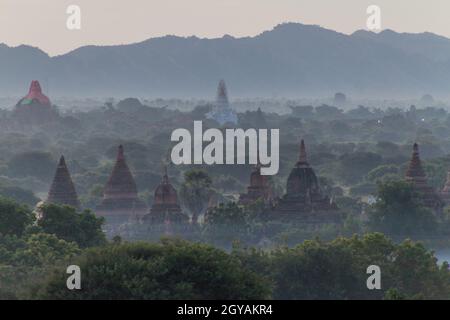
xmin=234 ymin=233 xmax=450 ymax=299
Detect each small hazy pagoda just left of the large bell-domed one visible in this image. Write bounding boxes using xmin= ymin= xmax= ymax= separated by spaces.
xmin=239 ymin=164 xmax=273 ymax=205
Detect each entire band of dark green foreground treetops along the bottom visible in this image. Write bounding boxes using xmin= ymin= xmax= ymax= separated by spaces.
xmin=22 ymin=233 xmax=450 ymax=299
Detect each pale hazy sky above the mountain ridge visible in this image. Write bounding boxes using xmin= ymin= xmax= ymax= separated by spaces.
xmin=0 ymin=0 xmax=450 ymax=55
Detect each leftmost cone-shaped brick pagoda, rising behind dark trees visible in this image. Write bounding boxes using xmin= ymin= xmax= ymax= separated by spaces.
xmin=45 ymin=156 xmax=80 ymax=209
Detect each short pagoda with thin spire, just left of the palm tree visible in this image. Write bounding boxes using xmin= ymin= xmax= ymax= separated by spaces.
xmin=144 ymin=168 xmax=189 ymax=225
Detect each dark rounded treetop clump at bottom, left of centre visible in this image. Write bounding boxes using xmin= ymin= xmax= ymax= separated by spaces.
xmin=38 ymin=240 xmax=270 ymax=299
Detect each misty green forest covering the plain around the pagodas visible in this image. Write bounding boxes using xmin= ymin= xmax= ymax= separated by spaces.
xmin=0 ymin=99 xmax=450 ymax=299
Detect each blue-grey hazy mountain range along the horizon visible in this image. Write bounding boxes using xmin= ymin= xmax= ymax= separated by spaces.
xmin=0 ymin=23 xmax=450 ymax=98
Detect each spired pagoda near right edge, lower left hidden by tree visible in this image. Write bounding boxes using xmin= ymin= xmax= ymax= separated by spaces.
xmin=405 ymin=143 xmax=443 ymax=213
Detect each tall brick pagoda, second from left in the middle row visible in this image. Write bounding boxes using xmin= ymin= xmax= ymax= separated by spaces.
xmin=96 ymin=145 xmax=147 ymax=224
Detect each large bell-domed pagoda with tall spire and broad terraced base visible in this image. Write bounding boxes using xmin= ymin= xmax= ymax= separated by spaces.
xmin=272 ymin=140 xmax=340 ymax=223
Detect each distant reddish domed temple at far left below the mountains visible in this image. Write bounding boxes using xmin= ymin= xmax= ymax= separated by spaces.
xmin=13 ymin=80 xmax=59 ymax=125
